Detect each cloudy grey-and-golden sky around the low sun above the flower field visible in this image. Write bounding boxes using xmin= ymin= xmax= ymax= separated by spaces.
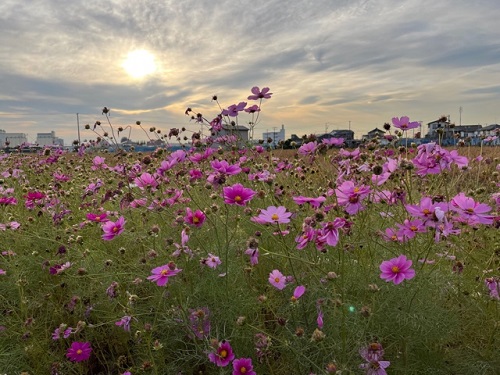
xmin=0 ymin=0 xmax=500 ymax=144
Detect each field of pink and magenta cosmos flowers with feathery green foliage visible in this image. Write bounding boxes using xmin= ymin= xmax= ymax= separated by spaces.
xmin=0 ymin=90 xmax=500 ymax=375
